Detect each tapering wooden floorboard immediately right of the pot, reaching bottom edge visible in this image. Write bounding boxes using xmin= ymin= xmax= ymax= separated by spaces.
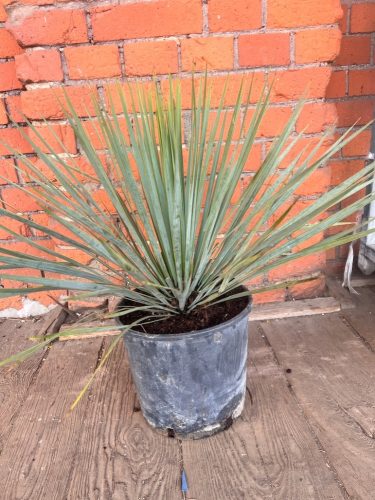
xmin=247 ymin=325 xmax=344 ymax=500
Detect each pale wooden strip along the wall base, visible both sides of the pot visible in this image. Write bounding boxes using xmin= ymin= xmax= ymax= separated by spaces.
xmin=59 ymin=297 xmax=341 ymax=342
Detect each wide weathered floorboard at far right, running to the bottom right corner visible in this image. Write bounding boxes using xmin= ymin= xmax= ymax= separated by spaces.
xmin=262 ymin=315 xmax=375 ymax=499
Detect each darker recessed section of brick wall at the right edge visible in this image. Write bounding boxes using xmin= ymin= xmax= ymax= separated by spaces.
xmin=326 ymin=0 xmax=375 ymax=272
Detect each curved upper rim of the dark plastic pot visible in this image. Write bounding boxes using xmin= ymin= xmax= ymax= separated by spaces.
xmin=115 ymin=285 xmax=253 ymax=341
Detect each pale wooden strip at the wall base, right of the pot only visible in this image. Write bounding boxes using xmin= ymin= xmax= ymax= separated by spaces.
xmin=249 ymin=297 xmax=340 ymax=321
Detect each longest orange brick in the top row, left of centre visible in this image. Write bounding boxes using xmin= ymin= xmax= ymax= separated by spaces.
xmin=91 ymin=0 xmax=202 ymax=41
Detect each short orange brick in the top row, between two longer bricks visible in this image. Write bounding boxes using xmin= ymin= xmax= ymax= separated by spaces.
xmin=208 ymin=0 xmax=262 ymax=32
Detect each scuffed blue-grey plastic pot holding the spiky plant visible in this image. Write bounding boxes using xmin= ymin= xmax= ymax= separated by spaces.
xmin=118 ymin=292 xmax=251 ymax=439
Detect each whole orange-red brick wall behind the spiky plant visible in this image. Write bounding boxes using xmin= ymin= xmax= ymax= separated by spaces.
xmin=0 ymin=0 xmax=375 ymax=308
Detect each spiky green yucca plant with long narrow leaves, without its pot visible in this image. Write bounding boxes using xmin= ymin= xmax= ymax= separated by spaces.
xmin=0 ymin=78 xmax=375 ymax=418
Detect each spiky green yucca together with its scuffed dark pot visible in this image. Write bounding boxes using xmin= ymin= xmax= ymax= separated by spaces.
xmin=0 ymin=78 xmax=375 ymax=438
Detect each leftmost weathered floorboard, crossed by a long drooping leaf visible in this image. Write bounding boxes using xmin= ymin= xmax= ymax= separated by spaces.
xmin=0 ymin=319 xmax=44 ymax=453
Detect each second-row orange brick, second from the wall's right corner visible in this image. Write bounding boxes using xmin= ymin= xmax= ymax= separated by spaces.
xmin=238 ymin=33 xmax=290 ymax=67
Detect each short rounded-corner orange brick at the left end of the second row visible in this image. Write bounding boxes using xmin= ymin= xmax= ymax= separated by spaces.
xmin=15 ymin=49 xmax=64 ymax=83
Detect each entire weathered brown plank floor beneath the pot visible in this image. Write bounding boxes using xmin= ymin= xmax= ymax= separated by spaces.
xmin=0 ymin=287 xmax=375 ymax=500
